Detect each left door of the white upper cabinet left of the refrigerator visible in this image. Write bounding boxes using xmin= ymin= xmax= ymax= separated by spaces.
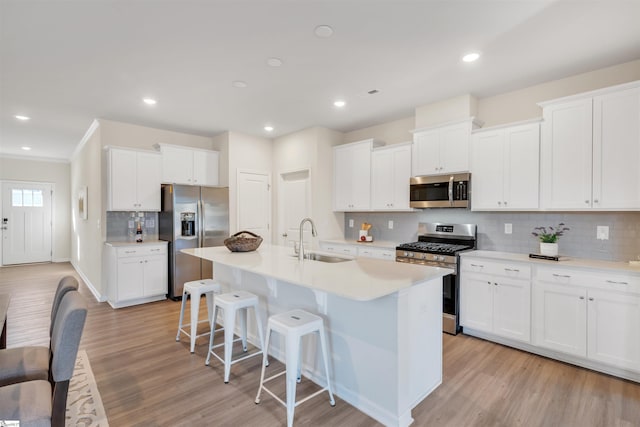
xmin=108 ymin=149 xmax=138 ymax=211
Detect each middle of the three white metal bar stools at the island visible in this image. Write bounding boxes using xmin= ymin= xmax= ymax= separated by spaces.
xmin=205 ymin=291 xmax=265 ymax=383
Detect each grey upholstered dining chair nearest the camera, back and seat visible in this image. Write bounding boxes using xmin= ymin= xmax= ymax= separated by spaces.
xmin=0 ymin=291 xmax=87 ymax=427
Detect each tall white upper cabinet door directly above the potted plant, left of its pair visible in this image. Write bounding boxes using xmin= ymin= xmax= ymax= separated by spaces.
xmin=541 ymin=98 xmax=592 ymax=209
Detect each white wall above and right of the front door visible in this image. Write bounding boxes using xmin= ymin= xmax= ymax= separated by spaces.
xmin=0 ymin=157 xmax=71 ymax=262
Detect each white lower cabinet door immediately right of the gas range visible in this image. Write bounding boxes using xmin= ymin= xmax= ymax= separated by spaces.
xmin=460 ymin=273 xmax=494 ymax=332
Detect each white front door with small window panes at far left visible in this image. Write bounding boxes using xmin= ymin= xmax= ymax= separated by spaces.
xmin=2 ymin=181 xmax=53 ymax=265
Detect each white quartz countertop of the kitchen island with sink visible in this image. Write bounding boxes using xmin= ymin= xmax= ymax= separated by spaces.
xmin=182 ymin=244 xmax=453 ymax=301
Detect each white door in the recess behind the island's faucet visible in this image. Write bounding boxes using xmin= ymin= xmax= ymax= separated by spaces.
xmin=278 ymin=169 xmax=311 ymax=247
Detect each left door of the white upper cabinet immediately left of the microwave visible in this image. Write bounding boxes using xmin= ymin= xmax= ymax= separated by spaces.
xmin=371 ymin=149 xmax=396 ymax=210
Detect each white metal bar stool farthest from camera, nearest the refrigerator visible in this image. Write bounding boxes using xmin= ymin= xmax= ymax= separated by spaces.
xmin=176 ymin=279 xmax=220 ymax=353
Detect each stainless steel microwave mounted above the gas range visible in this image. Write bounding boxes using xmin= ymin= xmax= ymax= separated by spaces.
xmin=409 ymin=173 xmax=471 ymax=208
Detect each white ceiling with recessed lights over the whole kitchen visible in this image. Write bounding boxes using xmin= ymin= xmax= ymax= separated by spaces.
xmin=0 ymin=0 xmax=640 ymax=159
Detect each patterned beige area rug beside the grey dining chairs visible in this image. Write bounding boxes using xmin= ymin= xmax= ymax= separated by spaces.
xmin=65 ymin=350 xmax=109 ymax=427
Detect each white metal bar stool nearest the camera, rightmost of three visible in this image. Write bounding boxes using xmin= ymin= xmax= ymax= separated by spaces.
xmin=256 ymin=310 xmax=336 ymax=427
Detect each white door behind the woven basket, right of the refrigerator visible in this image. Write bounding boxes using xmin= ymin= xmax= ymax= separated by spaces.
xmin=237 ymin=171 xmax=271 ymax=243
